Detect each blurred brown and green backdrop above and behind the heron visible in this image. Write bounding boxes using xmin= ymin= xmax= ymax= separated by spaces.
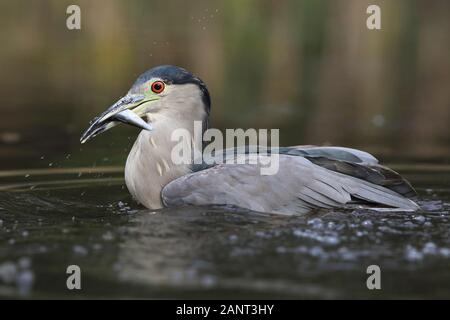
xmin=0 ymin=0 xmax=450 ymax=170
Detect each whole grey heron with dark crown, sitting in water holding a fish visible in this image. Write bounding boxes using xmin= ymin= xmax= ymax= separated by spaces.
xmin=81 ymin=65 xmax=419 ymax=214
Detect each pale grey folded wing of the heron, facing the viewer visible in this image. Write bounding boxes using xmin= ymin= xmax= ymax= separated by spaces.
xmin=162 ymin=154 xmax=418 ymax=214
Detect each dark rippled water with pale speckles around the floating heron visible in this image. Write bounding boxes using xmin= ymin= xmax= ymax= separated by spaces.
xmin=0 ymin=165 xmax=450 ymax=299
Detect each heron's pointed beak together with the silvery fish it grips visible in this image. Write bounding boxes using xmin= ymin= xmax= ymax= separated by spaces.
xmin=80 ymin=94 xmax=157 ymax=143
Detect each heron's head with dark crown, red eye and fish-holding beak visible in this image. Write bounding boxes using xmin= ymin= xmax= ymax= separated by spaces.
xmin=80 ymin=65 xmax=211 ymax=143
